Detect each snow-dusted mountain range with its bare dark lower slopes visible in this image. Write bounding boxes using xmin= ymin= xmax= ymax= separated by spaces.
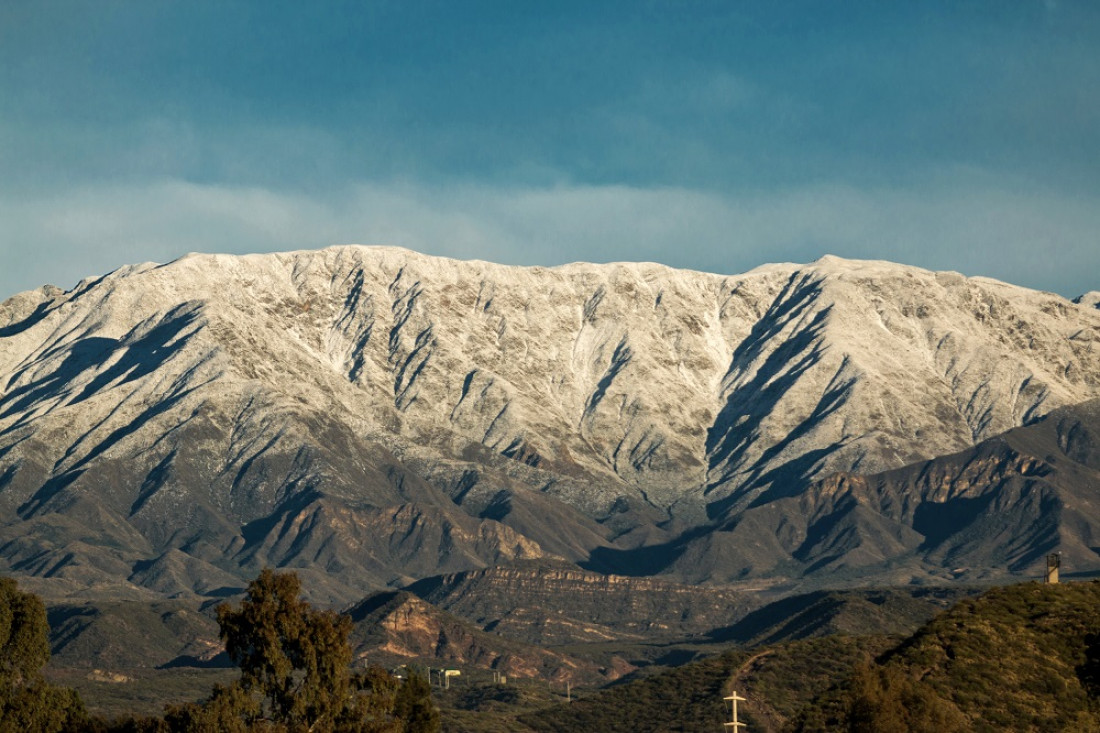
xmin=0 ymin=247 xmax=1100 ymax=601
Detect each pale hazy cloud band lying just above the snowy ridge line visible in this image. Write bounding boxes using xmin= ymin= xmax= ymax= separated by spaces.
xmin=0 ymin=176 xmax=1100 ymax=297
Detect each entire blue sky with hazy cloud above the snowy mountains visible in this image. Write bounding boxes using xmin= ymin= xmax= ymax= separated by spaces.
xmin=0 ymin=0 xmax=1100 ymax=297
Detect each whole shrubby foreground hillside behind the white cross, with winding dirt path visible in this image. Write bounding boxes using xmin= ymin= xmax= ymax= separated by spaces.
xmin=519 ymin=581 xmax=1100 ymax=733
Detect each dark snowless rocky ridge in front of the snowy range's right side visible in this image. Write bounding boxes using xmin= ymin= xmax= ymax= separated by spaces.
xmin=655 ymin=401 xmax=1100 ymax=583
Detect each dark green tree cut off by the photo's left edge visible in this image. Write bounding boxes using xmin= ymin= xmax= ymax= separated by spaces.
xmin=0 ymin=578 xmax=87 ymax=733
